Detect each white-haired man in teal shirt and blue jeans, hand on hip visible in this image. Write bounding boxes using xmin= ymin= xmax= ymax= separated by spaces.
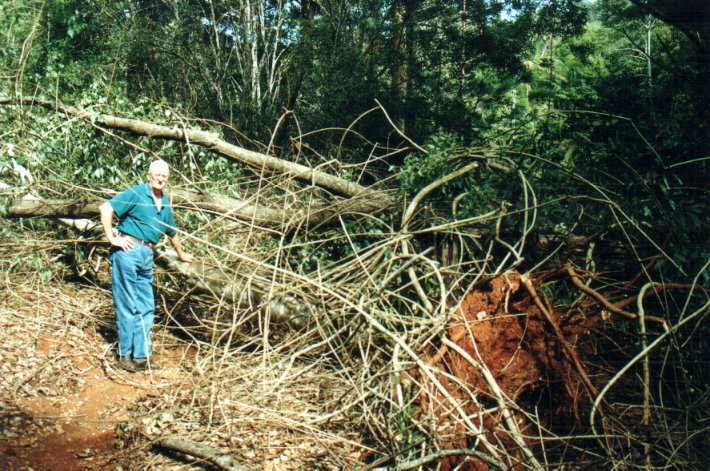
xmin=99 ymin=160 xmax=194 ymax=372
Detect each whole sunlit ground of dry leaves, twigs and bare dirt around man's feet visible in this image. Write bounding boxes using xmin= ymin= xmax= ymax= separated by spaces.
xmin=0 ymin=271 xmax=371 ymax=471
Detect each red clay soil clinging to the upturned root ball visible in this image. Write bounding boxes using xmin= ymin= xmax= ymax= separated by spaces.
xmin=421 ymin=272 xmax=579 ymax=471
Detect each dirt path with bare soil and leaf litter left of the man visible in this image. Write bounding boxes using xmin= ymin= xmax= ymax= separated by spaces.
xmin=0 ymin=284 xmax=191 ymax=471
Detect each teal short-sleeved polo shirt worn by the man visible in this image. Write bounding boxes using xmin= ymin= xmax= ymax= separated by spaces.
xmin=108 ymin=183 xmax=177 ymax=244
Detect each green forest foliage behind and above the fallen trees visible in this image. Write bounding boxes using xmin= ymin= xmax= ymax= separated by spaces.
xmin=0 ymin=0 xmax=710 ymax=284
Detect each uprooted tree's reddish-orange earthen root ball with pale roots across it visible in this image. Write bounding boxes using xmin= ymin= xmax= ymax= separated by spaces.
xmin=420 ymin=272 xmax=579 ymax=469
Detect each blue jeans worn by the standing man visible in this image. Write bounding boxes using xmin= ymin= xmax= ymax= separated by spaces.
xmin=110 ymin=244 xmax=155 ymax=361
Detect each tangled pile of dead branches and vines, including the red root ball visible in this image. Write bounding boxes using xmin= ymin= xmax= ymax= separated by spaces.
xmin=0 ymin=100 xmax=708 ymax=469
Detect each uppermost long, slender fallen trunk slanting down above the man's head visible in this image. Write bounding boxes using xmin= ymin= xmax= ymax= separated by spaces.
xmin=0 ymin=97 xmax=394 ymax=213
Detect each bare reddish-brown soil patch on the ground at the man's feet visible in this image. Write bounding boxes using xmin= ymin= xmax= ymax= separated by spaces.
xmin=0 ymin=329 xmax=195 ymax=471
